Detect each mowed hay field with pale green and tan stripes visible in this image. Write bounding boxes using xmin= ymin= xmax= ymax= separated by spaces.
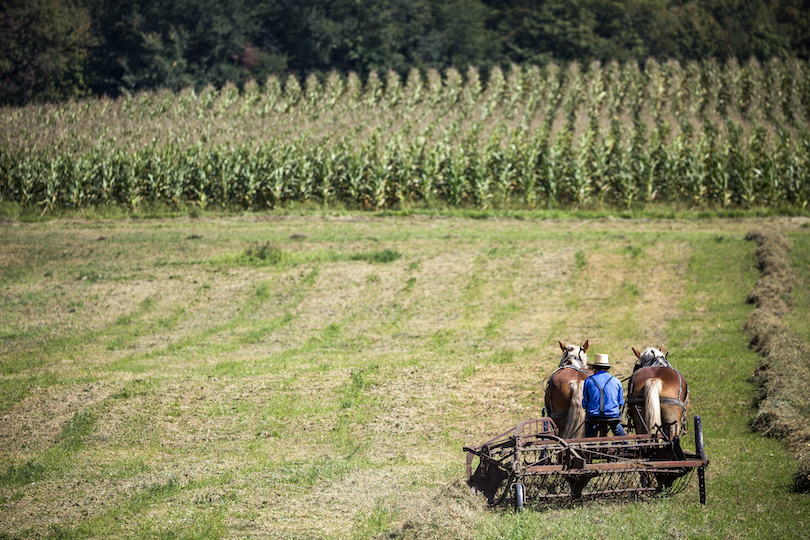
xmin=0 ymin=213 xmax=810 ymax=539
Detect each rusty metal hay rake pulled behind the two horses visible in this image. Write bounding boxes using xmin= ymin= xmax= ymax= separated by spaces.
xmin=464 ymin=416 xmax=709 ymax=508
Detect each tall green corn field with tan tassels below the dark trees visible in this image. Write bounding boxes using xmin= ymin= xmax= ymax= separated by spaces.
xmin=0 ymin=59 xmax=810 ymax=214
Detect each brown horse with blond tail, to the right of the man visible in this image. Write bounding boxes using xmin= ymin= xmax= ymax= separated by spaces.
xmin=627 ymin=346 xmax=689 ymax=439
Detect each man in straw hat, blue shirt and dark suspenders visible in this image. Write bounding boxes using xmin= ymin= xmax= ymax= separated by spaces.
xmin=582 ymin=354 xmax=626 ymax=437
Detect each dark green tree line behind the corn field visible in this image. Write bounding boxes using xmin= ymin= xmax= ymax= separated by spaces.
xmin=0 ymin=0 xmax=810 ymax=105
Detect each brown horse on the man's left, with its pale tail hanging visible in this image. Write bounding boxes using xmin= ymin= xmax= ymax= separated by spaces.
xmin=545 ymin=341 xmax=593 ymax=439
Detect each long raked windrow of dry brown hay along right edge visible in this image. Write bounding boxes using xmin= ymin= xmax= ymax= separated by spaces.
xmin=745 ymin=231 xmax=810 ymax=492
